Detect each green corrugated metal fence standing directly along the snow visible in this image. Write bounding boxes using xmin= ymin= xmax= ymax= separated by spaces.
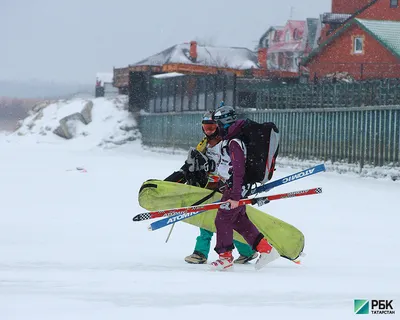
xmin=140 ymin=106 xmax=400 ymax=167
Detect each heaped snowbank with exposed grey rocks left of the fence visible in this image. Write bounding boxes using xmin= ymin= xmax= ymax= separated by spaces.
xmin=7 ymin=96 xmax=140 ymax=147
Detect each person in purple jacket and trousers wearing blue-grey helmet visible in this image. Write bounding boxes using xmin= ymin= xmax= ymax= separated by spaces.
xmin=211 ymin=106 xmax=280 ymax=270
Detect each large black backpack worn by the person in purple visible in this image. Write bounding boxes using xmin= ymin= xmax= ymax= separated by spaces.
xmin=237 ymin=119 xmax=279 ymax=184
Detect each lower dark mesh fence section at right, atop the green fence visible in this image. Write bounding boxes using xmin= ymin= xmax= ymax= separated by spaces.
xmin=237 ymin=79 xmax=400 ymax=109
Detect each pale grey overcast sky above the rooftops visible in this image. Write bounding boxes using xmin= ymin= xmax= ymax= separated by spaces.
xmin=0 ymin=0 xmax=330 ymax=83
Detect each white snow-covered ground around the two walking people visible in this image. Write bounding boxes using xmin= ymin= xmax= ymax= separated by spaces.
xmin=0 ymin=100 xmax=400 ymax=320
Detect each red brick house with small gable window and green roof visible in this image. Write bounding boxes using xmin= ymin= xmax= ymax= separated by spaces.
xmin=302 ymin=18 xmax=400 ymax=80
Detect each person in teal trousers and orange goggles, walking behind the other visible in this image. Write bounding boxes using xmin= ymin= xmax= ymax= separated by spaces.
xmin=166 ymin=111 xmax=258 ymax=264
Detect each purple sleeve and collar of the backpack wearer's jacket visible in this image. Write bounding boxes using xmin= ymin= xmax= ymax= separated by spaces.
xmin=222 ymin=120 xmax=246 ymax=201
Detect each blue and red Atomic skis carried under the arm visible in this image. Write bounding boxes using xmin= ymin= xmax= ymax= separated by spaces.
xmin=133 ymin=164 xmax=325 ymax=231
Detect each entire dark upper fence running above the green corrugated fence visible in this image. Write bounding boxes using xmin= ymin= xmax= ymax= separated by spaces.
xmin=128 ymin=72 xmax=400 ymax=113
